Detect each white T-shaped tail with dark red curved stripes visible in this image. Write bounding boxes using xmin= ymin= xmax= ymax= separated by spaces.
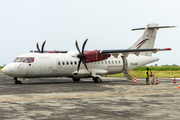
xmin=129 ymin=23 xmax=176 ymax=56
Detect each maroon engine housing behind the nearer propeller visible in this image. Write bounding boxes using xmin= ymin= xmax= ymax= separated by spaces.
xmin=84 ymin=50 xmax=111 ymax=63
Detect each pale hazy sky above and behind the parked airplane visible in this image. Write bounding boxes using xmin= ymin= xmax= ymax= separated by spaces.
xmin=0 ymin=0 xmax=180 ymax=65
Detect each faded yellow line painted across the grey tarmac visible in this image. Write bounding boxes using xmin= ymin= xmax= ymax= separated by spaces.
xmin=0 ymin=88 xmax=180 ymax=102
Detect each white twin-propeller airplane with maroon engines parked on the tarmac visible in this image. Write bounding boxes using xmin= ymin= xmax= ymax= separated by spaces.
xmin=2 ymin=23 xmax=175 ymax=84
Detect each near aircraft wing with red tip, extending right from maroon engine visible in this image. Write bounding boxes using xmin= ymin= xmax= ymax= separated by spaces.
xmin=100 ymin=48 xmax=171 ymax=57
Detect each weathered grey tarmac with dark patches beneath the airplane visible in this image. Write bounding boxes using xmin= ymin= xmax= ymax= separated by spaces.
xmin=0 ymin=73 xmax=180 ymax=120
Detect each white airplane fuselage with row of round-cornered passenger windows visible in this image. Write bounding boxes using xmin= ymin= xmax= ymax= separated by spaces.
xmin=2 ymin=53 xmax=159 ymax=78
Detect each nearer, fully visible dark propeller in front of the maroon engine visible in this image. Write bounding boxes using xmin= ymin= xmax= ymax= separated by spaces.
xmin=75 ymin=39 xmax=89 ymax=72
